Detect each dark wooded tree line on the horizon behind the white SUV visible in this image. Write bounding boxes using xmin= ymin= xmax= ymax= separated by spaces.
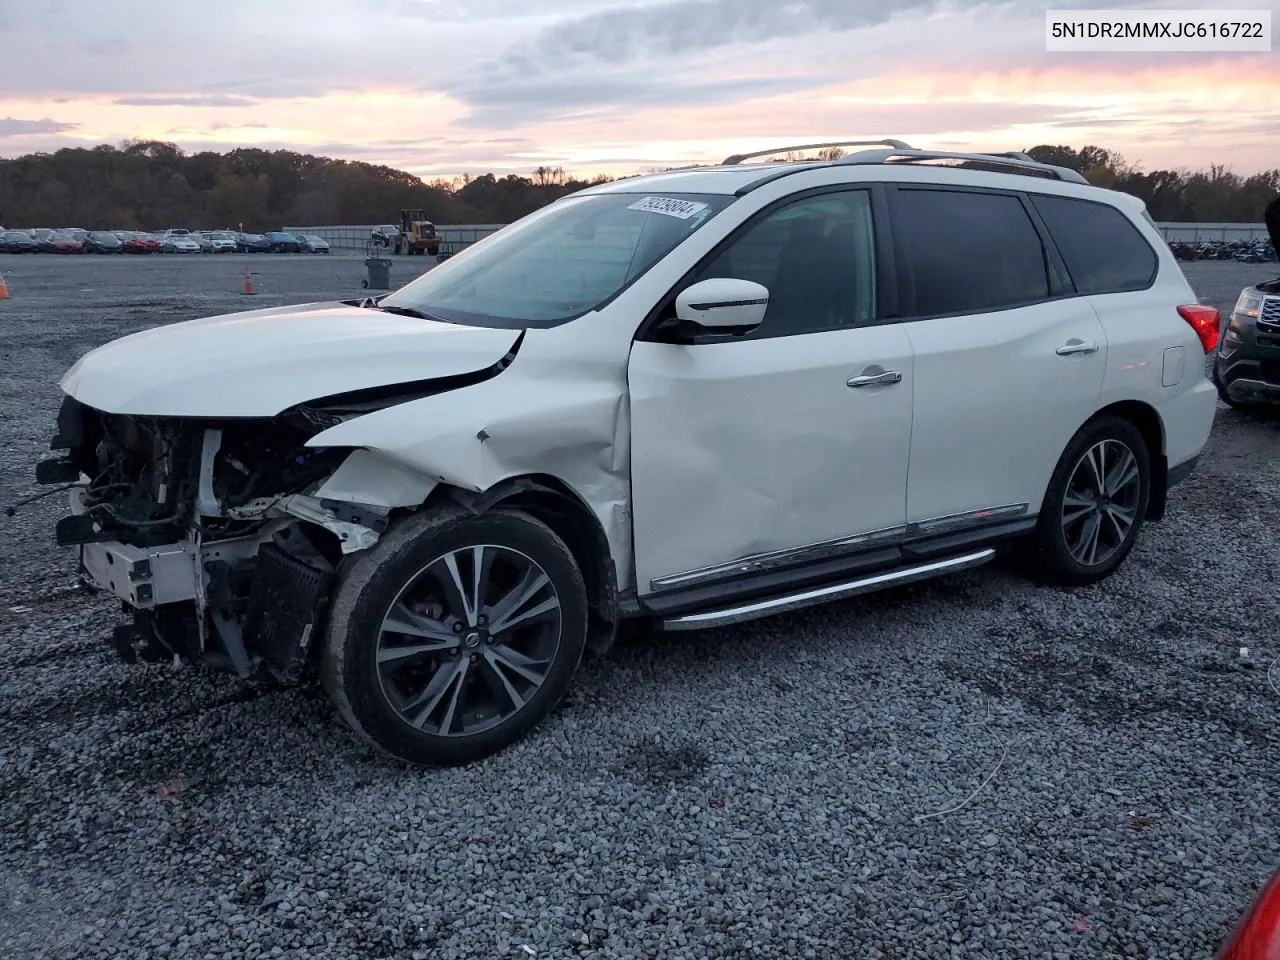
xmin=0 ymin=141 xmax=1280 ymax=232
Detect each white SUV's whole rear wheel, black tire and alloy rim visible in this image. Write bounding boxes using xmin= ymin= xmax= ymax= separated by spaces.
xmin=1032 ymin=416 xmax=1151 ymax=586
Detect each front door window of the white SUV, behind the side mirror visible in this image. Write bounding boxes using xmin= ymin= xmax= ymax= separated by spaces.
xmin=694 ymin=189 xmax=876 ymax=339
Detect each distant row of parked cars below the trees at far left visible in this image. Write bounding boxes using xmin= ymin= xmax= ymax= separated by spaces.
xmin=0 ymin=227 xmax=329 ymax=253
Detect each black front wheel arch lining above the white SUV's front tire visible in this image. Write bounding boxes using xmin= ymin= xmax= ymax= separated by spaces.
xmin=424 ymin=474 xmax=620 ymax=655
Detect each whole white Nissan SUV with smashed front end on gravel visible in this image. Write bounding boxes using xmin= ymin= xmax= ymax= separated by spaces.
xmin=38 ymin=141 xmax=1219 ymax=763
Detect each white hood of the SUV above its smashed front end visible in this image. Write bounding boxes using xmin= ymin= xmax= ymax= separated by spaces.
xmin=61 ymin=303 xmax=520 ymax=417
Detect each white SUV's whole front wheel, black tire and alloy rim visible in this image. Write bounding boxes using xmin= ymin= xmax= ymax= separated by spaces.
xmin=320 ymin=508 xmax=588 ymax=765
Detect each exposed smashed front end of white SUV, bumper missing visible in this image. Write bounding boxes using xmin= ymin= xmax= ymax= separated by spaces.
xmin=37 ymin=404 xmax=378 ymax=681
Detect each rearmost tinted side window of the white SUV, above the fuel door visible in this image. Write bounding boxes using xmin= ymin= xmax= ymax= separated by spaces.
xmin=1032 ymin=196 xmax=1157 ymax=293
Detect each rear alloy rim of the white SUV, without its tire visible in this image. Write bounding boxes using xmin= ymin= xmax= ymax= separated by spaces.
xmin=1062 ymin=439 xmax=1142 ymax=567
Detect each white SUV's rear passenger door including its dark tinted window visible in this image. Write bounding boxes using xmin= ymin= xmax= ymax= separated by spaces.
xmin=891 ymin=186 xmax=1107 ymax=534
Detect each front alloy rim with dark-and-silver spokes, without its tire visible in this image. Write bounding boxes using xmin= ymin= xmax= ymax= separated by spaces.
xmin=375 ymin=544 xmax=561 ymax=737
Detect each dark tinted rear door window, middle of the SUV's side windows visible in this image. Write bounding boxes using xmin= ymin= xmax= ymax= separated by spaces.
xmin=893 ymin=188 xmax=1048 ymax=316
